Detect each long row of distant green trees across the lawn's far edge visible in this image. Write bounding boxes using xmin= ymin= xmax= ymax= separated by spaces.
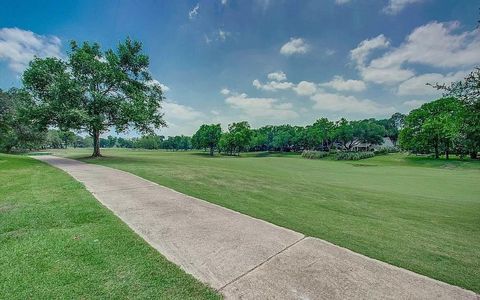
xmin=192 ymin=113 xmax=405 ymax=155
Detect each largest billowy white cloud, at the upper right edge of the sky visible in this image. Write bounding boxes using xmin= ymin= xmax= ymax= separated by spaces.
xmin=350 ymin=22 xmax=480 ymax=84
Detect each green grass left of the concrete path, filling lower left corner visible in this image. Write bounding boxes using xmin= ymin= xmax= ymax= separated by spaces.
xmin=0 ymin=155 xmax=220 ymax=299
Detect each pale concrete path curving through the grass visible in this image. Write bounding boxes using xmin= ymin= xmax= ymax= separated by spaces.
xmin=35 ymin=156 xmax=480 ymax=300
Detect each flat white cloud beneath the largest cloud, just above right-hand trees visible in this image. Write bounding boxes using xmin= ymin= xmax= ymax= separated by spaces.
xmin=397 ymin=71 xmax=468 ymax=96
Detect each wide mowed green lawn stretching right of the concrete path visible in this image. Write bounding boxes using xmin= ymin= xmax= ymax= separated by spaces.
xmin=58 ymin=149 xmax=480 ymax=293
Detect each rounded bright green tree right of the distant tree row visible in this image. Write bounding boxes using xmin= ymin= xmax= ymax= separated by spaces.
xmin=400 ymin=98 xmax=464 ymax=159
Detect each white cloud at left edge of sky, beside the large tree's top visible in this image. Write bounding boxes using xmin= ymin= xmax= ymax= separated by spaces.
xmin=0 ymin=28 xmax=62 ymax=73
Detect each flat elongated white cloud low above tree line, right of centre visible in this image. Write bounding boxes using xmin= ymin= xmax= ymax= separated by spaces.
xmin=310 ymin=92 xmax=395 ymax=116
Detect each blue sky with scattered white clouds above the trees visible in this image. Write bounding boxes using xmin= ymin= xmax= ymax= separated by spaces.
xmin=0 ymin=0 xmax=480 ymax=135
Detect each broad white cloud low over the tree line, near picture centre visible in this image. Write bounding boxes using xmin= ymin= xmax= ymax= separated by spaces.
xmin=225 ymin=93 xmax=298 ymax=120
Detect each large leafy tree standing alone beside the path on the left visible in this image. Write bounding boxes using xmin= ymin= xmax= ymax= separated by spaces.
xmin=23 ymin=39 xmax=165 ymax=156
